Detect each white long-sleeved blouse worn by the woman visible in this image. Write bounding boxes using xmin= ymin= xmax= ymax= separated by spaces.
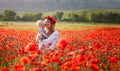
xmin=36 ymin=31 xmax=58 ymax=49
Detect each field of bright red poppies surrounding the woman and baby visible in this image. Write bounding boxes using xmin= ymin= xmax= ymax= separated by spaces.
xmin=0 ymin=27 xmax=120 ymax=71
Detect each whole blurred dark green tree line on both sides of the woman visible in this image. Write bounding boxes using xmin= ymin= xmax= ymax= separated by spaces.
xmin=0 ymin=10 xmax=120 ymax=23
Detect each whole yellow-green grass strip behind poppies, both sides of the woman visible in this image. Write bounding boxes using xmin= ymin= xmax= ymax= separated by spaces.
xmin=0 ymin=22 xmax=120 ymax=30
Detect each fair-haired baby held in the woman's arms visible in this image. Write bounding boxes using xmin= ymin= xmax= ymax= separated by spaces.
xmin=36 ymin=20 xmax=47 ymax=43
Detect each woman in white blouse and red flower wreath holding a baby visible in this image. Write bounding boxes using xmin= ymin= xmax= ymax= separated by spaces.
xmin=36 ymin=16 xmax=58 ymax=50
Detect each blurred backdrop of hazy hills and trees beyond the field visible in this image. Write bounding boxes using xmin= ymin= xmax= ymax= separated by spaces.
xmin=0 ymin=0 xmax=120 ymax=27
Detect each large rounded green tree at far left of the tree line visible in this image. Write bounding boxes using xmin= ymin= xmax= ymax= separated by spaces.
xmin=3 ymin=10 xmax=16 ymax=21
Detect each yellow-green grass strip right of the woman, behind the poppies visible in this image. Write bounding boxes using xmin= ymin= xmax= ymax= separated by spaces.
xmin=56 ymin=22 xmax=120 ymax=30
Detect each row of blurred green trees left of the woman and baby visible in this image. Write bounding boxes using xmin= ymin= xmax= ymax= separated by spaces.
xmin=0 ymin=10 xmax=43 ymax=21
